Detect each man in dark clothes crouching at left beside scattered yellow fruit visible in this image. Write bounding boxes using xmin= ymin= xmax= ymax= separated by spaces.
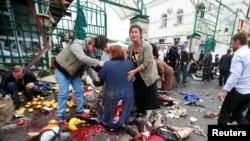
xmin=0 ymin=65 xmax=39 ymax=109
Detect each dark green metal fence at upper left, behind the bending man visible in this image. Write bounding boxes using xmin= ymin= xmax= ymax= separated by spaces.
xmin=0 ymin=0 xmax=107 ymax=69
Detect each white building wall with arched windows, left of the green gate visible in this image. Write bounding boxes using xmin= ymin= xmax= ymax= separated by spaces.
xmin=146 ymin=0 xmax=195 ymax=44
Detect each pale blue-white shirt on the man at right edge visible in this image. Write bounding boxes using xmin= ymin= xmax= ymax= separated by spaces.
xmin=223 ymin=45 xmax=250 ymax=94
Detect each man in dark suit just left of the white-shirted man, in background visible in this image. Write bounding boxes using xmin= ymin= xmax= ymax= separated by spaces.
xmin=219 ymin=49 xmax=233 ymax=86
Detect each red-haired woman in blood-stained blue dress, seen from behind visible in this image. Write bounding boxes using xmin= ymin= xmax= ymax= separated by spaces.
xmin=93 ymin=45 xmax=142 ymax=138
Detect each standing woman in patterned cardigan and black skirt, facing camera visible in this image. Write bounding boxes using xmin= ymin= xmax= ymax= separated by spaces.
xmin=127 ymin=24 xmax=160 ymax=119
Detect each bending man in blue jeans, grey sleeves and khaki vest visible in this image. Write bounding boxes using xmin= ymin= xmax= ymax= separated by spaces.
xmin=53 ymin=35 xmax=108 ymax=122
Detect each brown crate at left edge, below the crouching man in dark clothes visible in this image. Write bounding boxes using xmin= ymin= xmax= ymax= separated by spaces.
xmin=0 ymin=100 xmax=15 ymax=126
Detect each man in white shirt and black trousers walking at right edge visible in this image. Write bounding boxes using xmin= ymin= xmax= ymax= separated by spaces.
xmin=217 ymin=33 xmax=250 ymax=125
